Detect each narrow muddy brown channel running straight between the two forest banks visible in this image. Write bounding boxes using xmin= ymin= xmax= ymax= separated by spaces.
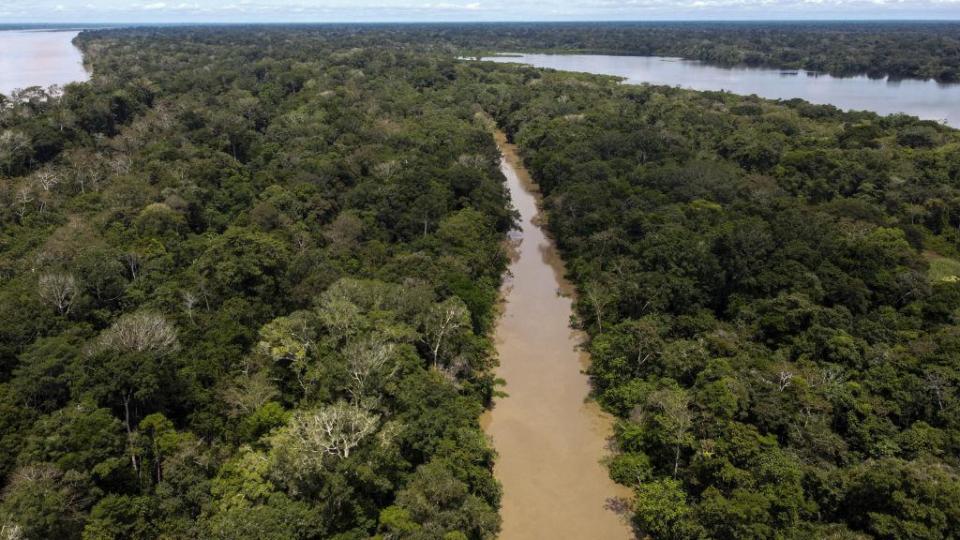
xmin=483 ymin=132 xmax=632 ymax=540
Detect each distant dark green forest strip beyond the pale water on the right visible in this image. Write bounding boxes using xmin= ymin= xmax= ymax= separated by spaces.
xmin=402 ymin=21 xmax=960 ymax=82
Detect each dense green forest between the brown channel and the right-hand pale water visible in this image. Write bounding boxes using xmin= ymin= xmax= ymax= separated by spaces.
xmin=498 ymin=64 xmax=960 ymax=539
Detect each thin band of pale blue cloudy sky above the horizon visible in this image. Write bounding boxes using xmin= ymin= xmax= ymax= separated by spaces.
xmin=0 ymin=0 xmax=960 ymax=23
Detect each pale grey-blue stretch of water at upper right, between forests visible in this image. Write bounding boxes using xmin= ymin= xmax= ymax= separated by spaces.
xmin=482 ymin=54 xmax=960 ymax=128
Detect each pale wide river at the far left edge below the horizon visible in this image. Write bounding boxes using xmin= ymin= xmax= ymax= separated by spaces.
xmin=0 ymin=30 xmax=89 ymax=96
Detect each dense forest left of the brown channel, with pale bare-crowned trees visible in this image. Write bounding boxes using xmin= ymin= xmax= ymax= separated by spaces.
xmin=0 ymin=29 xmax=513 ymax=540
